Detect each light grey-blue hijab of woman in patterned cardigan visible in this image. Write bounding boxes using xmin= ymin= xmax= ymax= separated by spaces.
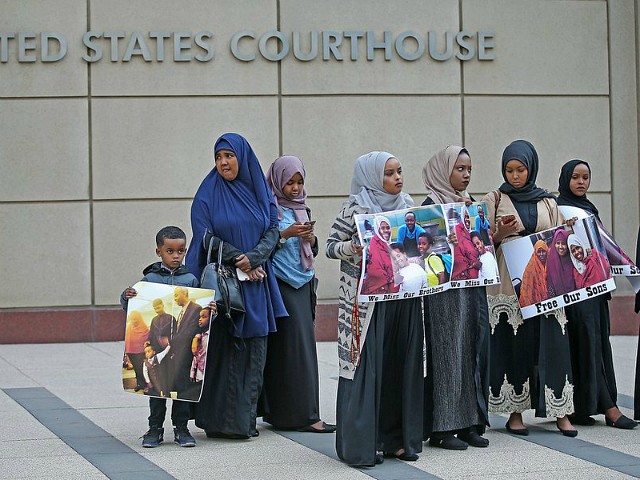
xmin=349 ymin=151 xmax=413 ymax=213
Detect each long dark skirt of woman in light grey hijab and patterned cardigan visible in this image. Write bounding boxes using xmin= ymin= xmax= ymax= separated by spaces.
xmin=336 ymin=298 xmax=424 ymax=466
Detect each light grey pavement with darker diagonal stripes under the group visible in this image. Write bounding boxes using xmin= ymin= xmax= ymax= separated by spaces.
xmin=0 ymin=336 xmax=640 ymax=480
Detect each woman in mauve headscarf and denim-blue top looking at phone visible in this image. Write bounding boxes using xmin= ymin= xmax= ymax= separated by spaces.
xmin=261 ymin=156 xmax=336 ymax=433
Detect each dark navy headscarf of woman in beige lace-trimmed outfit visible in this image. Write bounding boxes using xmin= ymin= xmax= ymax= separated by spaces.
xmin=500 ymin=140 xmax=555 ymax=235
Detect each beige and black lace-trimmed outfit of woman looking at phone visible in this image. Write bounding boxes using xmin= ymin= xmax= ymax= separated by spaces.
xmin=482 ymin=191 xmax=574 ymax=418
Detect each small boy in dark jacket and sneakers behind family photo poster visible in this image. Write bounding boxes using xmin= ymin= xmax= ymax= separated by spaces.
xmin=120 ymin=226 xmax=216 ymax=448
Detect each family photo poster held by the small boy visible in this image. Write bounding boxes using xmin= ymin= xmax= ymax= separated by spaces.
xmin=122 ymin=282 xmax=214 ymax=402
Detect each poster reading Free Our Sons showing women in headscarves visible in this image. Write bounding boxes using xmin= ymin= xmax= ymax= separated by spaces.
xmin=502 ymin=216 xmax=616 ymax=318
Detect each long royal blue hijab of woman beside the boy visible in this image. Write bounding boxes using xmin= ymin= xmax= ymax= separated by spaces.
xmin=185 ymin=133 xmax=287 ymax=338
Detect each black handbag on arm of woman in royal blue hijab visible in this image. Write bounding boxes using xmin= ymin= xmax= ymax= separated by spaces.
xmin=200 ymin=238 xmax=245 ymax=317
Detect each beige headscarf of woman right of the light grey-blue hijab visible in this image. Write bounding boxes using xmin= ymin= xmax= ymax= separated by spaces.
xmin=422 ymin=145 xmax=469 ymax=203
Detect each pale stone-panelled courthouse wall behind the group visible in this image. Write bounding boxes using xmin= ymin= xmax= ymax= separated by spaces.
xmin=0 ymin=0 xmax=639 ymax=342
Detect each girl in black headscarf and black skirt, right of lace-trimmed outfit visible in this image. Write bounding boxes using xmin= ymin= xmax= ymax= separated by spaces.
xmin=558 ymin=159 xmax=636 ymax=429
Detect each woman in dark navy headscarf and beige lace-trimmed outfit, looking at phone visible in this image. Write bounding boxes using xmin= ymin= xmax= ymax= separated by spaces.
xmin=482 ymin=140 xmax=577 ymax=437
